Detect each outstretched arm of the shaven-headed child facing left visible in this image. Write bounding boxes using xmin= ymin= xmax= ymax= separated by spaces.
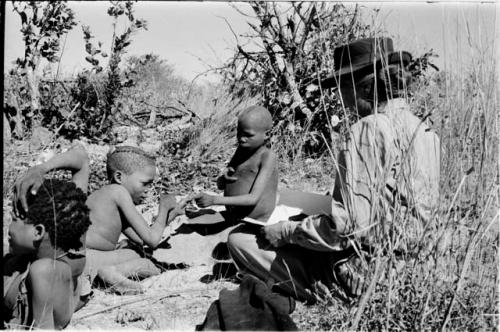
xmin=195 ymin=152 xmax=276 ymax=207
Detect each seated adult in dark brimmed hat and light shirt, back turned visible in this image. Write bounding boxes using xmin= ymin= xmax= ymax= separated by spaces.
xmin=228 ymin=38 xmax=440 ymax=302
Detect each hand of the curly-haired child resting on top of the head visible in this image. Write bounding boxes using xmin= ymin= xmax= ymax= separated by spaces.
xmin=12 ymin=166 xmax=45 ymax=216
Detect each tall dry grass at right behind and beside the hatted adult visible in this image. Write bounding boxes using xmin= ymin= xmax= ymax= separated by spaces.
xmin=285 ymin=35 xmax=500 ymax=331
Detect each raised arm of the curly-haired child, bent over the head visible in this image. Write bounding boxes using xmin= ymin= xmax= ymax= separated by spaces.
xmin=13 ymin=145 xmax=89 ymax=213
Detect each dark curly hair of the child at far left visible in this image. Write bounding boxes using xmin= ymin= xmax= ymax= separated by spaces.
xmin=27 ymin=179 xmax=90 ymax=251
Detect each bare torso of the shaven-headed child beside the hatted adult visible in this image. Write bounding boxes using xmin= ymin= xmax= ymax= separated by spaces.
xmin=224 ymin=146 xmax=278 ymax=220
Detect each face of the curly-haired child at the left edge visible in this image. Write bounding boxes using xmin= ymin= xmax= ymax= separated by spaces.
xmin=9 ymin=215 xmax=37 ymax=255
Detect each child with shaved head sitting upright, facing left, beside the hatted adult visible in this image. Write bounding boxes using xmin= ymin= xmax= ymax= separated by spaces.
xmin=194 ymin=106 xmax=278 ymax=221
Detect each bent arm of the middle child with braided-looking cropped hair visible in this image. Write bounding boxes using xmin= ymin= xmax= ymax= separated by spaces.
xmin=113 ymin=186 xmax=176 ymax=249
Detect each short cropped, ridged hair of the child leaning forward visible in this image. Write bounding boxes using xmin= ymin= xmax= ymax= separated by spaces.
xmin=106 ymin=146 xmax=156 ymax=179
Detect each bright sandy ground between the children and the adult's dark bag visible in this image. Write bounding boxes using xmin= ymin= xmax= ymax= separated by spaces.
xmin=68 ymin=213 xmax=242 ymax=330
